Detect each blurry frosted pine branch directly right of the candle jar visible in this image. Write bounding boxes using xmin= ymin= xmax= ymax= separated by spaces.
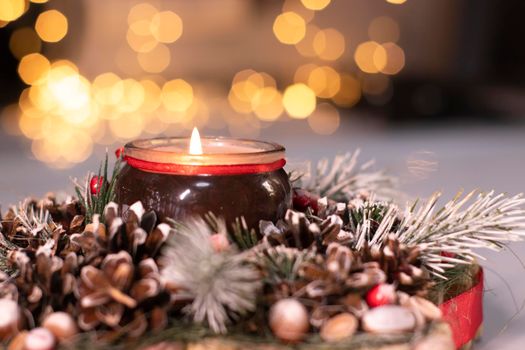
xmin=292 ymin=149 xmax=400 ymax=201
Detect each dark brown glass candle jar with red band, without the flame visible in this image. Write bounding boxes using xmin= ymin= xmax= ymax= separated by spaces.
xmin=117 ymin=137 xmax=292 ymax=229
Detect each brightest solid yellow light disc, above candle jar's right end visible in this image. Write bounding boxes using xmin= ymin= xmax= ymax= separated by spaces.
xmin=283 ymin=83 xmax=317 ymax=119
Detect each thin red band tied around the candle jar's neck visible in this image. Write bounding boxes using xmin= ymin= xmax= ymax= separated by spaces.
xmin=124 ymin=156 xmax=286 ymax=175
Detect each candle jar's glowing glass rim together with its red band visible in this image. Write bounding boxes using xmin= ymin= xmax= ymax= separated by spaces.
xmin=122 ymin=137 xmax=286 ymax=175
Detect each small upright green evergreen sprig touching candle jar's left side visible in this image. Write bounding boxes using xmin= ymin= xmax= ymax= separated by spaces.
xmin=73 ymin=152 xmax=122 ymax=223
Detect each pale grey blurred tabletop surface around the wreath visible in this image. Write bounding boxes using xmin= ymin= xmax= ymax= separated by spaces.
xmin=0 ymin=119 xmax=525 ymax=349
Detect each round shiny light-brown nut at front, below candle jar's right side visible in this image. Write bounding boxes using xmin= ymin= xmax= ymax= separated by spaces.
xmin=269 ymin=298 xmax=310 ymax=343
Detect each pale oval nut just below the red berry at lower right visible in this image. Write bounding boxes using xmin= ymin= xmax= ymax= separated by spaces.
xmin=361 ymin=305 xmax=416 ymax=334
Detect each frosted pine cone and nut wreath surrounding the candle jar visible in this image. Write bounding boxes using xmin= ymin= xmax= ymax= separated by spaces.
xmin=0 ymin=152 xmax=525 ymax=350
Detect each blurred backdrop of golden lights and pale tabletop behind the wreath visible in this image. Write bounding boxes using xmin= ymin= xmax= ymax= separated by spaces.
xmin=0 ymin=0 xmax=525 ymax=349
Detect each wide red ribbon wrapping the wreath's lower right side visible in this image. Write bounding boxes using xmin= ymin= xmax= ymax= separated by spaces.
xmin=439 ymin=268 xmax=483 ymax=349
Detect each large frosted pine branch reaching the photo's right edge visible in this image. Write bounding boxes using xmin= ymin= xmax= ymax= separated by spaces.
xmin=355 ymin=191 xmax=525 ymax=277
